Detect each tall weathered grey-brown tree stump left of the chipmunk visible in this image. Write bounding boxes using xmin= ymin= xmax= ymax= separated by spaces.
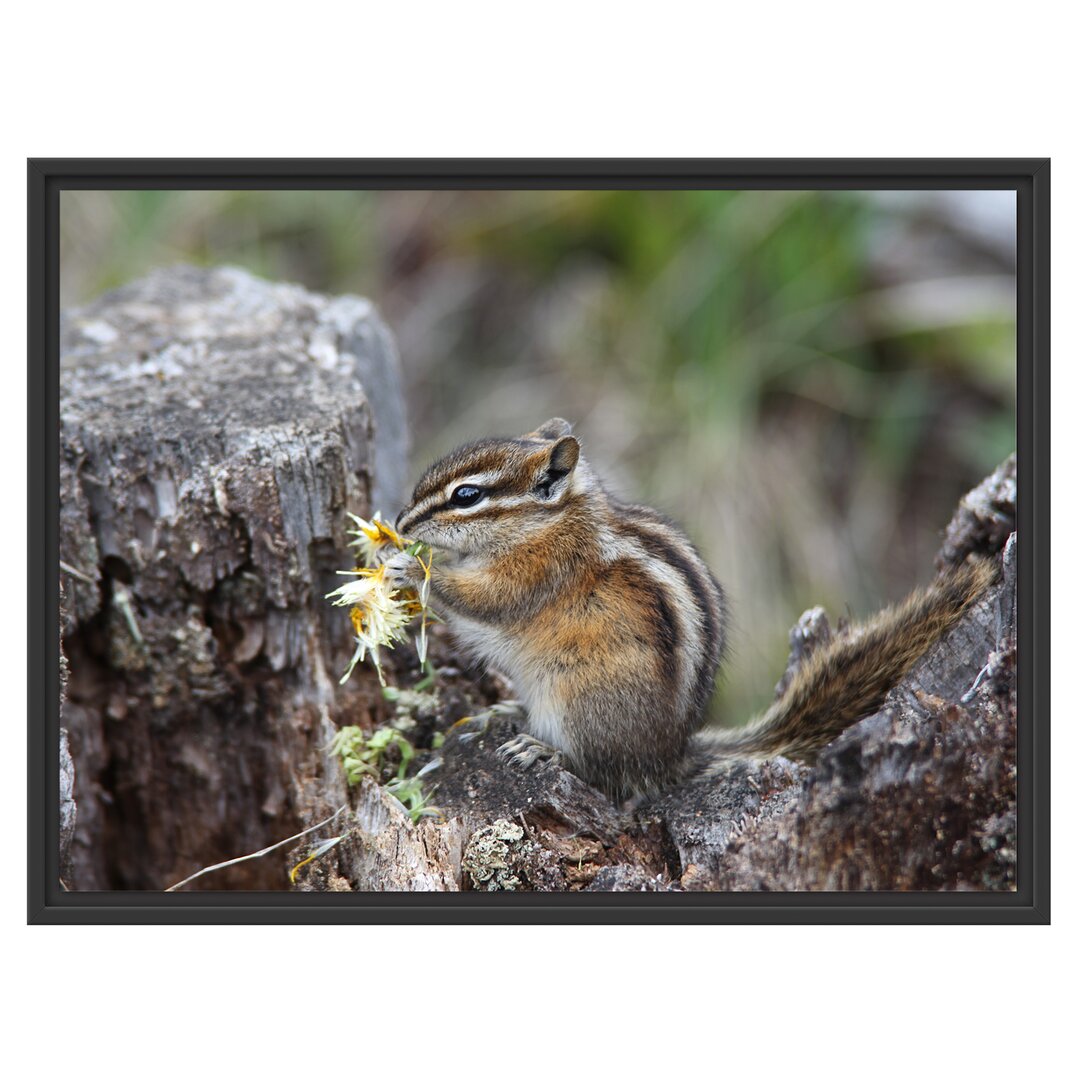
xmin=60 ymin=268 xmax=406 ymax=889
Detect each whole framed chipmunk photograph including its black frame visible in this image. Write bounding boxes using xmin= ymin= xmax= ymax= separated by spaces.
xmin=28 ymin=160 xmax=1050 ymax=922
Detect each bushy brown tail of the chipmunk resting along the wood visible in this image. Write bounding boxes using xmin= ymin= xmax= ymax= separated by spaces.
xmin=698 ymin=559 xmax=998 ymax=760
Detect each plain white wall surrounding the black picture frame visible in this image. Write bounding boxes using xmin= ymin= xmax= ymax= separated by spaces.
xmin=0 ymin=0 xmax=1078 ymax=1077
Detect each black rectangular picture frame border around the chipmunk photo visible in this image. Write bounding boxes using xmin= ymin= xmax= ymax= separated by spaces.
xmin=27 ymin=159 xmax=1050 ymax=923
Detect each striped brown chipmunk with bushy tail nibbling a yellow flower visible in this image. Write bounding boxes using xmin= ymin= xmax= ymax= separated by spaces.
xmin=386 ymin=418 xmax=996 ymax=800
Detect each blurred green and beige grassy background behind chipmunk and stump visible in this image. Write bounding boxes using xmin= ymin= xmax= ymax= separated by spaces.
xmin=60 ymin=191 xmax=1016 ymax=723
